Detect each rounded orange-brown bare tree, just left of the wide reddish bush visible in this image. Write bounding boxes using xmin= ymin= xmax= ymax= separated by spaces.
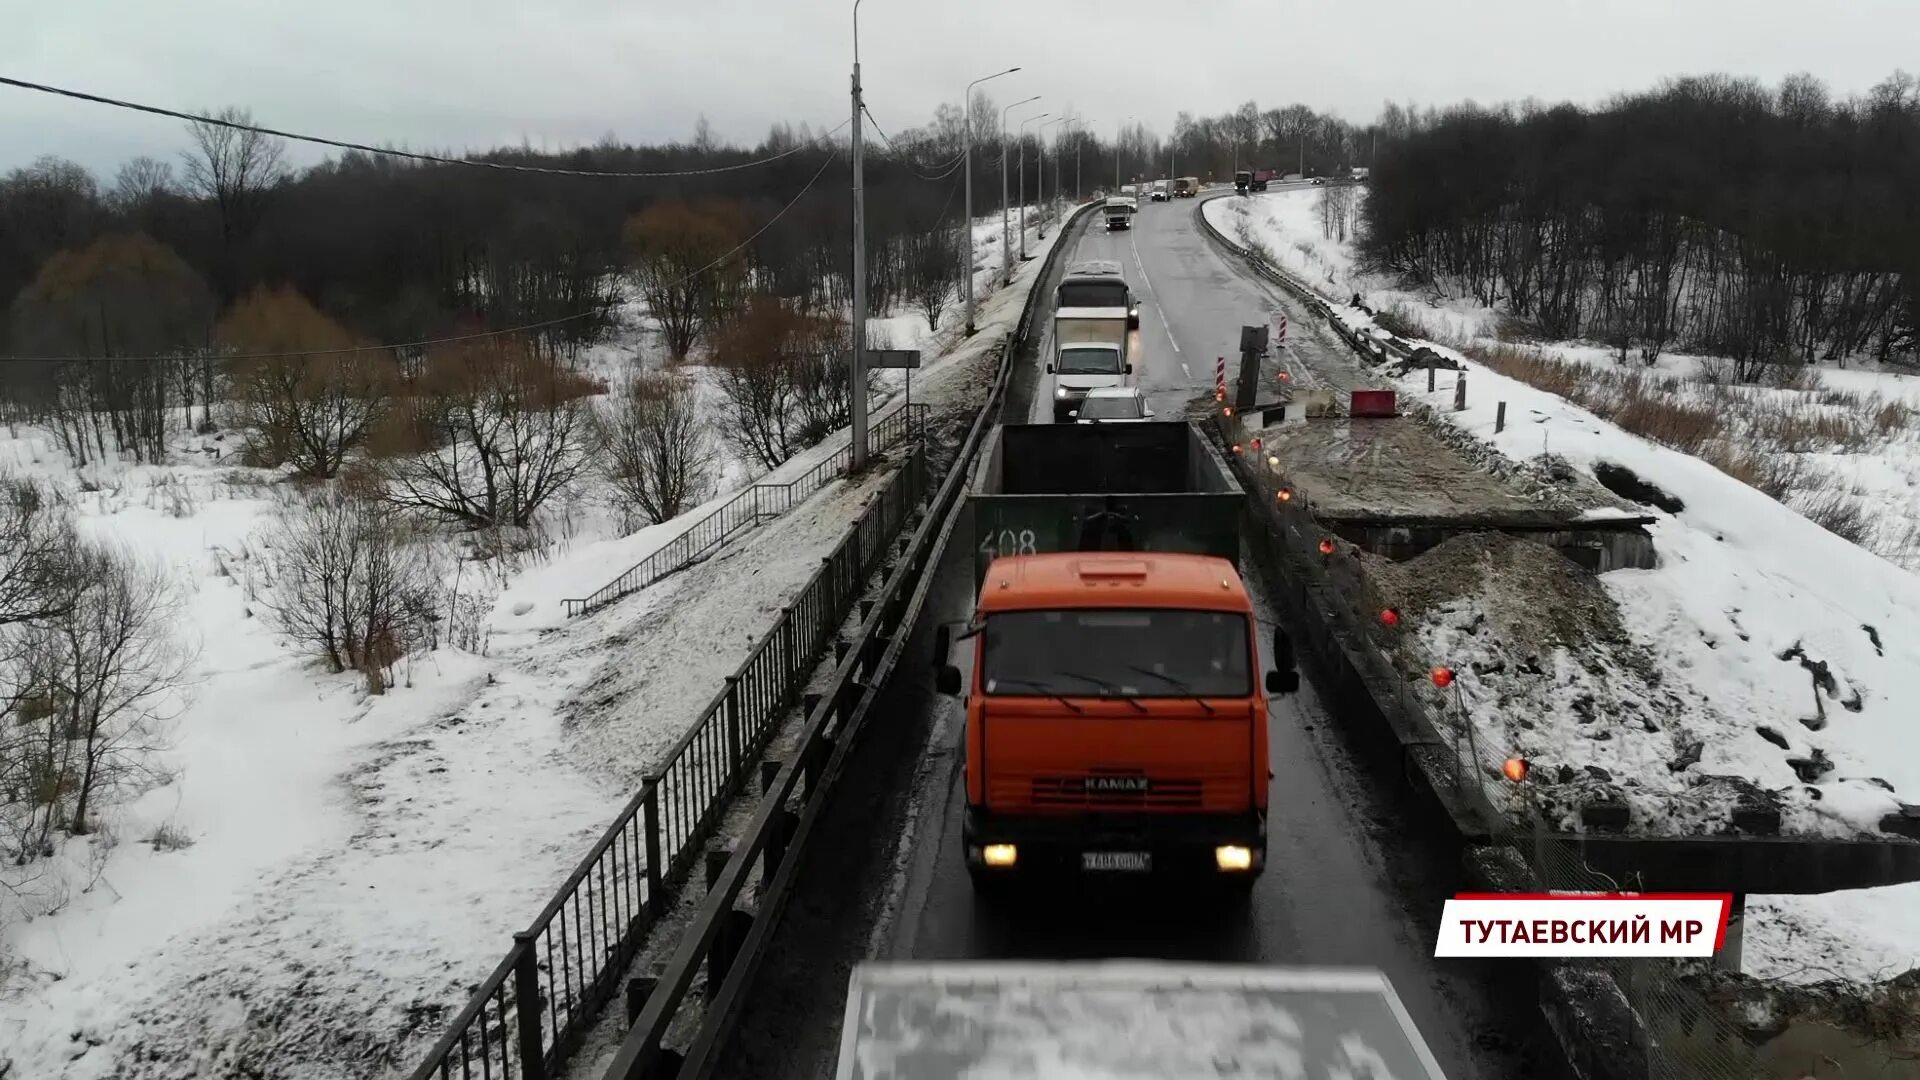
xmin=217 ymin=288 xmax=392 ymax=479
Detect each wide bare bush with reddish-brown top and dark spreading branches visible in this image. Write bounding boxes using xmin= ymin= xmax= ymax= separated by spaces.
xmin=376 ymin=338 xmax=603 ymax=528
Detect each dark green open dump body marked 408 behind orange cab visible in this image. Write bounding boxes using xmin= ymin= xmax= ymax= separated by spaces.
xmin=968 ymin=421 xmax=1244 ymax=584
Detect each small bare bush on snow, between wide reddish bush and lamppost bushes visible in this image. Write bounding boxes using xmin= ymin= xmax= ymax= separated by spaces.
xmin=595 ymin=375 xmax=718 ymax=523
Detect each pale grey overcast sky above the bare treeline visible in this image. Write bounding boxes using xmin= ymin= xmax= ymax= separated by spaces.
xmin=0 ymin=0 xmax=1920 ymax=179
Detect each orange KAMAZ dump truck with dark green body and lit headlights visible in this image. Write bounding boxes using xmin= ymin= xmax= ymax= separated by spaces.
xmin=935 ymin=421 xmax=1300 ymax=890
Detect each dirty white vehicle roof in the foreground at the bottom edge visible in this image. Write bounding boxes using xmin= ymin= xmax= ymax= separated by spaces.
xmin=835 ymin=961 xmax=1444 ymax=1080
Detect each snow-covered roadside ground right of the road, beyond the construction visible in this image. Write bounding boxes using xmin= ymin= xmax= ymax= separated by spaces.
xmin=1206 ymin=192 xmax=1920 ymax=982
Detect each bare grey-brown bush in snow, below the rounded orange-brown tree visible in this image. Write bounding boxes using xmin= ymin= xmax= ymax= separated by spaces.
xmin=265 ymin=490 xmax=436 ymax=694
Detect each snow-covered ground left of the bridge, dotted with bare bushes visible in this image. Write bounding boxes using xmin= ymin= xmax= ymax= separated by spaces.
xmin=0 ymin=205 xmax=1052 ymax=1080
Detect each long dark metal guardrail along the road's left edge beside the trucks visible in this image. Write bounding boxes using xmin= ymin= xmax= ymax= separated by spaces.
xmin=605 ymin=204 xmax=1091 ymax=1080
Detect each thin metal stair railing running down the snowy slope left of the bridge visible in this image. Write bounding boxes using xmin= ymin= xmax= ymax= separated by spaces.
xmin=561 ymin=404 xmax=927 ymax=619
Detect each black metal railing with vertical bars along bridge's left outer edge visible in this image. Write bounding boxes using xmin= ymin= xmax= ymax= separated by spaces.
xmin=413 ymin=434 xmax=927 ymax=1080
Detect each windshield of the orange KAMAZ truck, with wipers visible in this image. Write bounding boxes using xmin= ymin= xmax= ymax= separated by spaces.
xmin=981 ymin=607 xmax=1254 ymax=698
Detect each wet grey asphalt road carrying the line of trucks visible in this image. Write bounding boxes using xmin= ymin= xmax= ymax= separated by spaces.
xmin=706 ymin=200 xmax=1563 ymax=1080
